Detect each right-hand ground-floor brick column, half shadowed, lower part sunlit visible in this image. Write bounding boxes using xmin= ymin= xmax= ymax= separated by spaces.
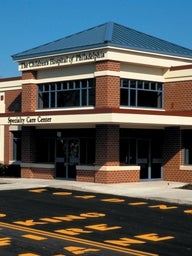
xmin=163 ymin=127 xmax=182 ymax=181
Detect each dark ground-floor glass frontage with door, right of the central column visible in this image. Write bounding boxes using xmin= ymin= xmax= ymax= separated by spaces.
xmin=120 ymin=129 xmax=163 ymax=179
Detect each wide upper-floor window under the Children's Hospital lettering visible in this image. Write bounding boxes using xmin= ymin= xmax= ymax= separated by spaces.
xmin=38 ymin=79 xmax=95 ymax=109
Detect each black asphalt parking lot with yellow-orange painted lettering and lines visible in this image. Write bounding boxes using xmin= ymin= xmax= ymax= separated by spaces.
xmin=0 ymin=188 xmax=192 ymax=256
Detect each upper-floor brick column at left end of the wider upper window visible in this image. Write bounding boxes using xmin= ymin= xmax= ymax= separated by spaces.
xmin=22 ymin=71 xmax=37 ymax=112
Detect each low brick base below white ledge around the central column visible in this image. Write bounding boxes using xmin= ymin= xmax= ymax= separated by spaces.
xmin=76 ymin=170 xmax=140 ymax=184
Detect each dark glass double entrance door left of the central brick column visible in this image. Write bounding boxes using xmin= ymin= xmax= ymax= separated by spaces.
xmin=56 ymin=138 xmax=80 ymax=179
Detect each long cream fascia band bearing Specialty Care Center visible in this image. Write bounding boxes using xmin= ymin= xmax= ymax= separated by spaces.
xmin=0 ymin=113 xmax=192 ymax=127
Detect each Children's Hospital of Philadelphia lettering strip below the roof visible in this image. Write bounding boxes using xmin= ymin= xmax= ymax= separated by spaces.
xmin=19 ymin=50 xmax=105 ymax=71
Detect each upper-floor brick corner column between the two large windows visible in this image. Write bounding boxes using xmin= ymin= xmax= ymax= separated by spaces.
xmin=96 ymin=61 xmax=120 ymax=108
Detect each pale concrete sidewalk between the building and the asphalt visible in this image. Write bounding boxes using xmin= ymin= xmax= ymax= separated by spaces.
xmin=0 ymin=178 xmax=192 ymax=205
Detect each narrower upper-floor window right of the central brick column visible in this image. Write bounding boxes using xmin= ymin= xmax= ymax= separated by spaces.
xmin=120 ymin=79 xmax=163 ymax=108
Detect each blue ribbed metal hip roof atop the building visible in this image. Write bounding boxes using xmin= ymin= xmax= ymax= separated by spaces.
xmin=12 ymin=22 xmax=192 ymax=61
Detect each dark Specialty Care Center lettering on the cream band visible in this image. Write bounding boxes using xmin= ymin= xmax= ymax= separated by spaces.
xmin=8 ymin=116 xmax=52 ymax=125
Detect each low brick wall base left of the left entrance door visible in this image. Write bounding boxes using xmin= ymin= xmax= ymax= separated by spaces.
xmin=21 ymin=167 xmax=55 ymax=179
